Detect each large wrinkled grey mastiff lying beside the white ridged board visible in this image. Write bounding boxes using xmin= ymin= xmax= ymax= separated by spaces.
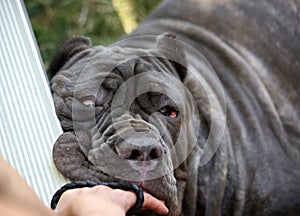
xmin=49 ymin=0 xmax=300 ymax=216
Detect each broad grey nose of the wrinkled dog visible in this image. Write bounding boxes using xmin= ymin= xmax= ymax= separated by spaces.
xmin=115 ymin=143 xmax=163 ymax=161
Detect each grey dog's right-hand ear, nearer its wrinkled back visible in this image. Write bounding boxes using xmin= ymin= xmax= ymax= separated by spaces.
xmin=156 ymin=33 xmax=187 ymax=80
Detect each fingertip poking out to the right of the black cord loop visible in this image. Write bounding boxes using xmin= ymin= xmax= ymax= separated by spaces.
xmin=143 ymin=192 xmax=169 ymax=214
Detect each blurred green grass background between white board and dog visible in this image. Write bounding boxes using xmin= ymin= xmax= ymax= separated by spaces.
xmin=24 ymin=0 xmax=161 ymax=72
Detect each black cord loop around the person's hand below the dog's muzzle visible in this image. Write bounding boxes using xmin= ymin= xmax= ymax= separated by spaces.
xmin=50 ymin=181 xmax=144 ymax=215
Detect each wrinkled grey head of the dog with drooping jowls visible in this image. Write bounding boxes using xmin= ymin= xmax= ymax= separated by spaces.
xmin=51 ymin=36 xmax=199 ymax=215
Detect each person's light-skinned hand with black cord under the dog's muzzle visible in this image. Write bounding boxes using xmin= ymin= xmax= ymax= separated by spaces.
xmin=56 ymin=185 xmax=168 ymax=216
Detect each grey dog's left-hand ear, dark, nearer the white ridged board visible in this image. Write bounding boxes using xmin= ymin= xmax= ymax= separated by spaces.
xmin=48 ymin=36 xmax=91 ymax=77
